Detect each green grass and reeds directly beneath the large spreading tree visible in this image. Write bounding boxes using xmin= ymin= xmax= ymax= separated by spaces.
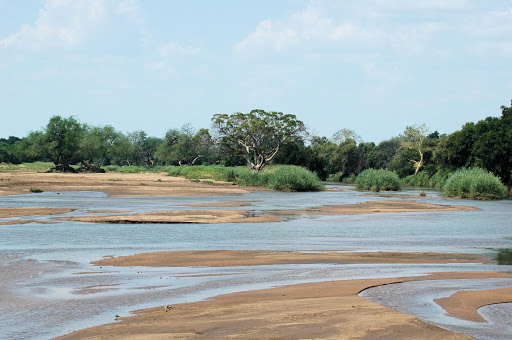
xmin=169 ymin=165 xmax=324 ymax=191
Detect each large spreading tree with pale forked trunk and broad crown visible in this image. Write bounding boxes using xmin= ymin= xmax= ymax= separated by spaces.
xmin=212 ymin=110 xmax=307 ymax=171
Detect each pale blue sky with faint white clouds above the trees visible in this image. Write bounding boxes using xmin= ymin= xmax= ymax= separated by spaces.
xmin=0 ymin=0 xmax=512 ymax=142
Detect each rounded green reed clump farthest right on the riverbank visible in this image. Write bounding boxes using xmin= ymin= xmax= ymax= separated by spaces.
xmin=443 ymin=168 xmax=507 ymax=199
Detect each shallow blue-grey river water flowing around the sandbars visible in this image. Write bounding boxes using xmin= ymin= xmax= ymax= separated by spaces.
xmin=0 ymin=185 xmax=512 ymax=339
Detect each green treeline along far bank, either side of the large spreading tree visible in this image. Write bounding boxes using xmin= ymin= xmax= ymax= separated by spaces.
xmin=0 ymin=99 xmax=512 ymax=187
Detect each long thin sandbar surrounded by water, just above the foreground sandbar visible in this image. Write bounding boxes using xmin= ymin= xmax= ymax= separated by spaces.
xmin=92 ymin=250 xmax=490 ymax=267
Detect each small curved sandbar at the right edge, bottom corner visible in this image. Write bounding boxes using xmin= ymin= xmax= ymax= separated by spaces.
xmin=434 ymin=288 xmax=512 ymax=322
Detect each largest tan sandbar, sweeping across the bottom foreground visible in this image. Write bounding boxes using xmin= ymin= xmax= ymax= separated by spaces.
xmin=57 ymin=272 xmax=512 ymax=339
